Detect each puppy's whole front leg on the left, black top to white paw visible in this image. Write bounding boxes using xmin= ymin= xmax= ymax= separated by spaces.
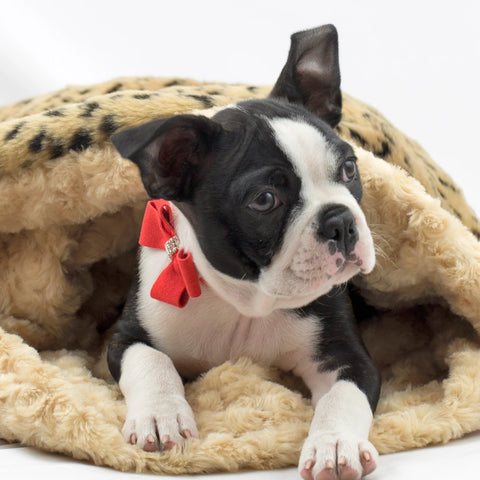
xmin=108 ymin=282 xmax=198 ymax=451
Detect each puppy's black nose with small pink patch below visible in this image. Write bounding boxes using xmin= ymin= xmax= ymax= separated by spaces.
xmin=317 ymin=204 xmax=358 ymax=256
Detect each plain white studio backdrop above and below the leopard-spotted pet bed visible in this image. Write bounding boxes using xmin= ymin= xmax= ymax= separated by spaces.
xmin=0 ymin=0 xmax=480 ymax=480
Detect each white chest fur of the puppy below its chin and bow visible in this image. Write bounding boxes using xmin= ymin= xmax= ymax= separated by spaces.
xmin=138 ymin=247 xmax=320 ymax=377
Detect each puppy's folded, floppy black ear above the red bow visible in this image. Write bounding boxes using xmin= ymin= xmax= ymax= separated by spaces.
xmin=111 ymin=115 xmax=222 ymax=201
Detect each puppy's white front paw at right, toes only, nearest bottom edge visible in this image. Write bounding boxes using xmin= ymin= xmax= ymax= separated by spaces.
xmin=298 ymin=433 xmax=378 ymax=480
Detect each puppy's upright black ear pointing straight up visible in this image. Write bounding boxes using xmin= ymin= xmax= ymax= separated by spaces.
xmin=270 ymin=25 xmax=342 ymax=127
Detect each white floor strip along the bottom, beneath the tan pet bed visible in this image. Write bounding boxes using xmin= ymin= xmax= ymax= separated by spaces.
xmin=0 ymin=432 xmax=480 ymax=480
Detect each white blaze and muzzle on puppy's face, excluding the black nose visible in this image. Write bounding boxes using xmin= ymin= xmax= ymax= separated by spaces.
xmin=259 ymin=118 xmax=375 ymax=298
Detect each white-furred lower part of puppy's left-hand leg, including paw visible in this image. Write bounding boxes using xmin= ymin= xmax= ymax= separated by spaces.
xmin=119 ymin=343 xmax=198 ymax=451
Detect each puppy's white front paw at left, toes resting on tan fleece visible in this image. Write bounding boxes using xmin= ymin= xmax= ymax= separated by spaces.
xmin=122 ymin=395 xmax=198 ymax=452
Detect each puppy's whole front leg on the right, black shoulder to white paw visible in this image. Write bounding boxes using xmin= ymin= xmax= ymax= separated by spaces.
xmin=294 ymin=288 xmax=381 ymax=480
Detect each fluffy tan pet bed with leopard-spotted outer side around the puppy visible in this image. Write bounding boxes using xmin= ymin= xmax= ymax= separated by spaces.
xmin=0 ymin=78 xmax=480 ymax=473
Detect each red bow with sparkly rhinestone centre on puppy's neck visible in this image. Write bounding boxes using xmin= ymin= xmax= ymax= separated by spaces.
xmin=139 ymin=200 xmax=202 ymax=308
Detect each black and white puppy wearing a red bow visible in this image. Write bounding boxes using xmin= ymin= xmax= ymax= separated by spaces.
xmin=108 ymin=26 xmax=380 ymax=480
